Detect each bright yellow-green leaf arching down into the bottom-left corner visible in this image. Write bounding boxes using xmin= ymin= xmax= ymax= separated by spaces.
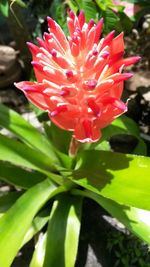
xmin=0 ymin=180 xmax=58 ymax=267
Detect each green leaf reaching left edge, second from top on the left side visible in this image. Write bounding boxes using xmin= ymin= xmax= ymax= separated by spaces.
xmin=0 ymin=134 xmax=55 ymax=172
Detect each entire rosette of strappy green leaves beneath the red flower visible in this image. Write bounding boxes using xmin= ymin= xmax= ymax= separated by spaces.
xmin=0 ymin=102 xmax=150 ymax=267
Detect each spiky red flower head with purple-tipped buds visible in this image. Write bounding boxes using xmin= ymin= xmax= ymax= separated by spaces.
xmin=16 ymin=11 xmax=139 ymax=142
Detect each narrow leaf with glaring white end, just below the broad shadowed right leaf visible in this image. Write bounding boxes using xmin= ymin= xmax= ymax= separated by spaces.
xmin=77 ymin=190 xmax=150 ymax=244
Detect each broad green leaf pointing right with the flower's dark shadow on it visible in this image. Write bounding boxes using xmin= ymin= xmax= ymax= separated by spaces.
xmin=65 ymin=150 xmax=150 ymax=210
